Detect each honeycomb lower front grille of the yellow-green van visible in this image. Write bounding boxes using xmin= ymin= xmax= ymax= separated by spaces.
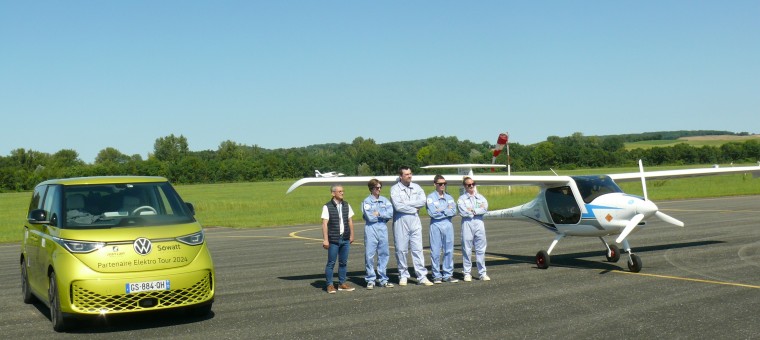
xmin=72 ymin=273 xmax=212 ymax=313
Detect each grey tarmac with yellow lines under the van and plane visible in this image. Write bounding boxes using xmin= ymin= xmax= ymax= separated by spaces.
xmin=0 ymin=196 xmax=760 ymax=339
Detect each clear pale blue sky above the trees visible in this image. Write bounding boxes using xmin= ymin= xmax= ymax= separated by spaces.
xmin=0 ymin=0 xmax=760 ymax=163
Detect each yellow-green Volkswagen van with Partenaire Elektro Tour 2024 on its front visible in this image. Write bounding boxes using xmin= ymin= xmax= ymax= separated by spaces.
xmin=20 ymin=176 xmax=215 ymax=331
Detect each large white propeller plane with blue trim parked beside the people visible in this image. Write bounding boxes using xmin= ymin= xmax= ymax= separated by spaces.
xmin=288 ymin=161 xmax=760 ymax=272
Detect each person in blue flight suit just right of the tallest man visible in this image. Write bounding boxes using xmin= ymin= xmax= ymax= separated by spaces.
xmin=427 ymin=175 xmax=459 ymax=283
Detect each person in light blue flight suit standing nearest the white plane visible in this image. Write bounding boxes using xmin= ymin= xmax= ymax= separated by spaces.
xmin=457 ymin=177 xmax=491 ymax=282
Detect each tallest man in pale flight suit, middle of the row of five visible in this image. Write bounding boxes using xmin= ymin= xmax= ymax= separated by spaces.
xmin=391 ymin=166 xmax=433 ymax=286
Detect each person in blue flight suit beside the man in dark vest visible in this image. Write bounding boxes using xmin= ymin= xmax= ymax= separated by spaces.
xmin=362 ymin=178 xmax=393 ymax=289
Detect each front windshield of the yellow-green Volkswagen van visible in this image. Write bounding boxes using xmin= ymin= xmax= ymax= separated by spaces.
xmin=63 ymin=182 xmax=195 ymax=229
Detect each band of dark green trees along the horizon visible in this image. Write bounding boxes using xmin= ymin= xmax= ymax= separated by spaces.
xmin=0 ymin=131 xmax=760 ymax=192
